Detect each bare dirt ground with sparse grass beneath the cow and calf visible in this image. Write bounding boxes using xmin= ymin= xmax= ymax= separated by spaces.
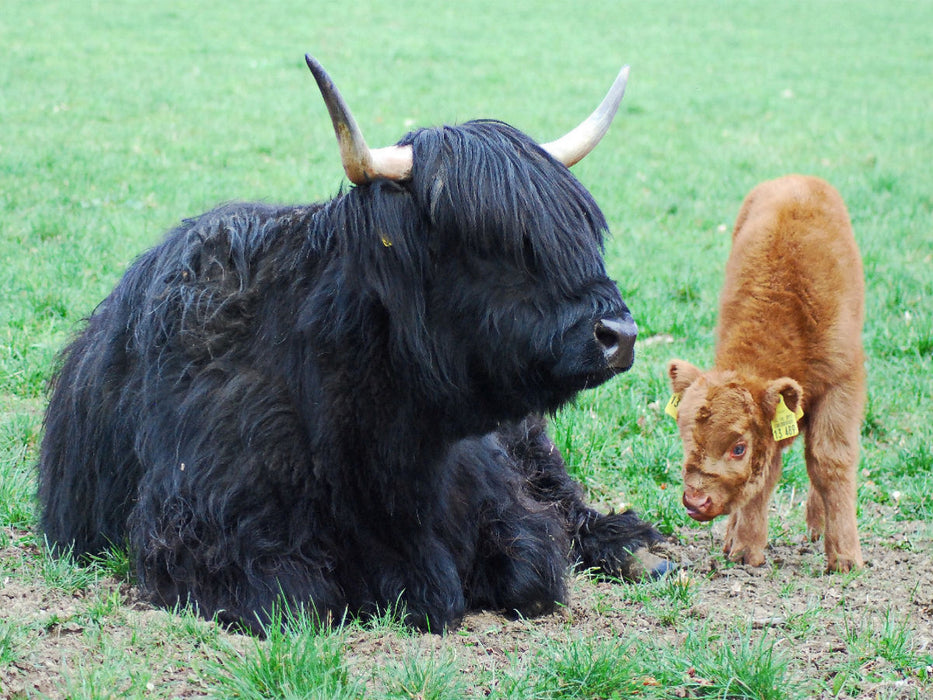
xmin=0 ymin=512 xmax=933 ymax=698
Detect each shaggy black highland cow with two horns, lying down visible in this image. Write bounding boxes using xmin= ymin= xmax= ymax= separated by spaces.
xmin=39 ymin=58 xmax=667 ymax=631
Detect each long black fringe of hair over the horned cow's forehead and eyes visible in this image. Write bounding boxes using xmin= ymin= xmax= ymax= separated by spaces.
xmin=400 ymin=120 xmax=608 ymax=278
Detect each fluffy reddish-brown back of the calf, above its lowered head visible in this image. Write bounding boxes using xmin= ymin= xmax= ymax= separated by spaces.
xmin=716 ymin=175 xmax=864 ymax=393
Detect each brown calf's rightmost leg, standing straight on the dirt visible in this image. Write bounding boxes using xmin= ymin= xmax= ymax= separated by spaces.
xmin=804 ymin=385 xmax=864 ymax=571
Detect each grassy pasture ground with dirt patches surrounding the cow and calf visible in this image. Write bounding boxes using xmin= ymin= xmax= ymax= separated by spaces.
xmin=0 ymin=0 xmax=933 ymax=698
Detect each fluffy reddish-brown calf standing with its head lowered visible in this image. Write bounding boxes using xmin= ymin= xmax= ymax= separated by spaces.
xmin=668 ymin=175 xmax=865 ymax=571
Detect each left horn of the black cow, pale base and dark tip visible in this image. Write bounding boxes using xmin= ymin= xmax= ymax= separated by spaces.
xmin=305 ymin=54 xmax=412 ymax=185
